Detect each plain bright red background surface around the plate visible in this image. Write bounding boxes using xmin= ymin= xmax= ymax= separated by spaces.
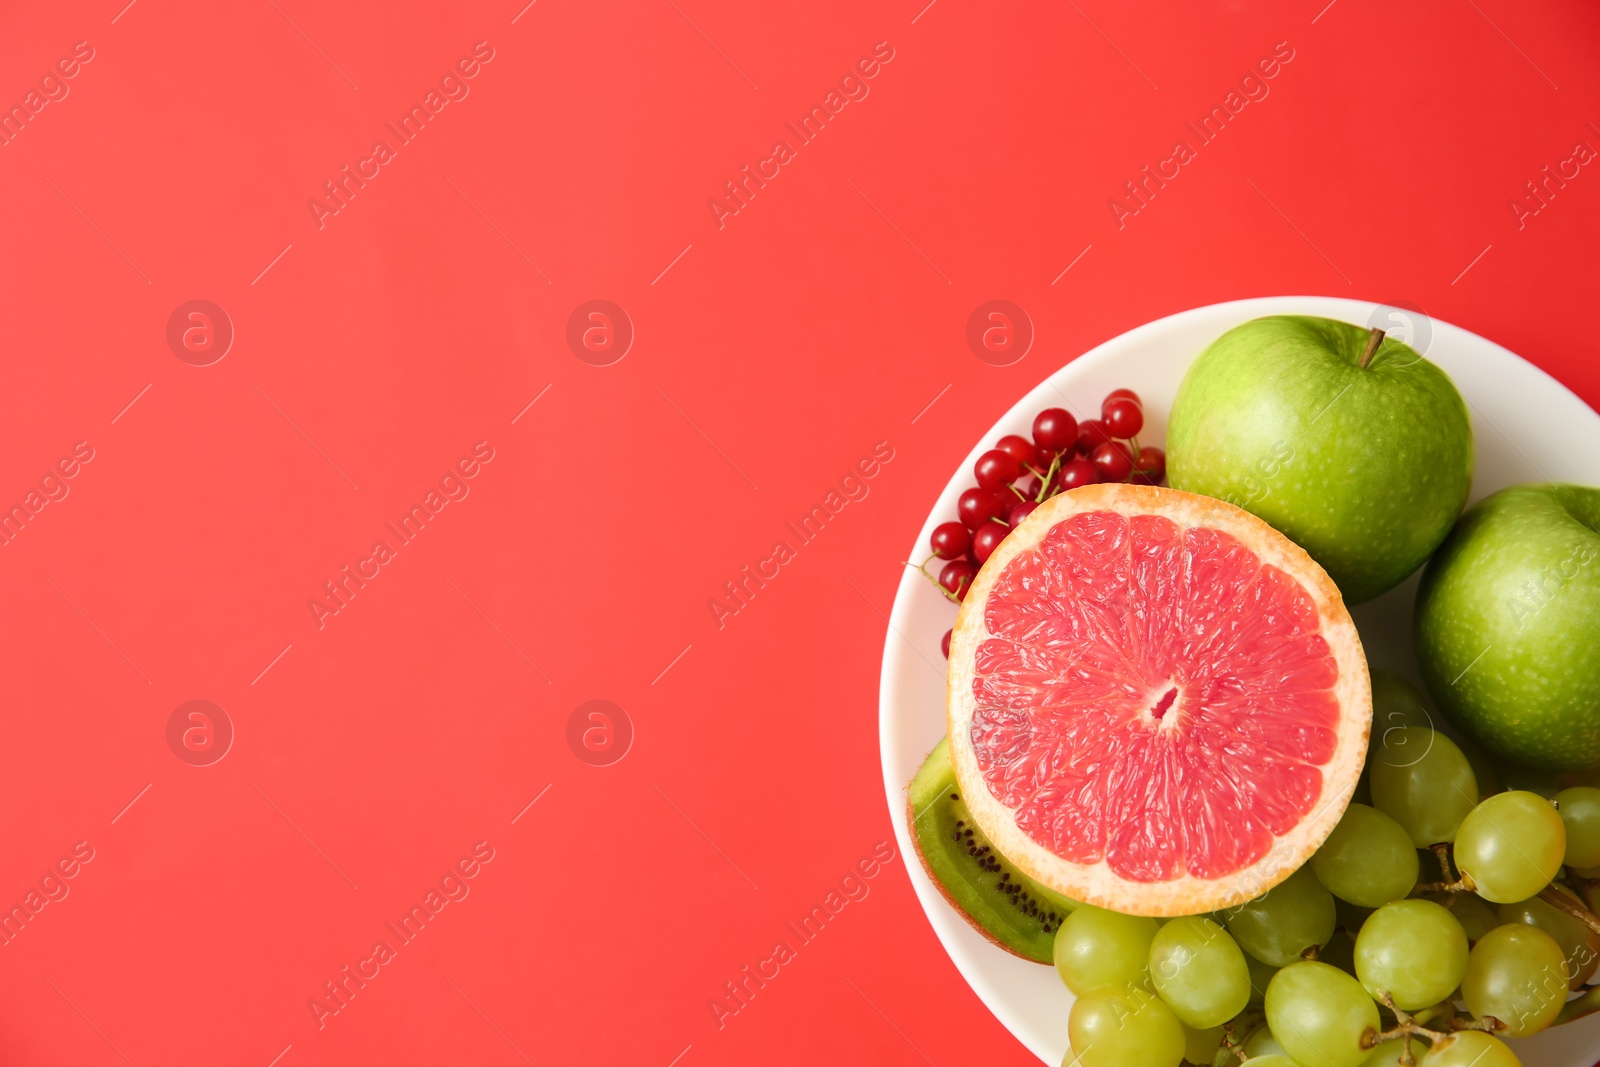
xmin=0 ymin=0 xmax=1600 ymax=1067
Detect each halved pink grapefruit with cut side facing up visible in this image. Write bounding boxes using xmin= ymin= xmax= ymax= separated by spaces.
xmin=947 ymin=485 xmax=1371 ymax=915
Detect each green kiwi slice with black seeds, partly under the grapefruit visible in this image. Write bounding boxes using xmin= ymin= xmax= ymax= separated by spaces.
xmin=906 ymin=737 xmax=1077 ymax=963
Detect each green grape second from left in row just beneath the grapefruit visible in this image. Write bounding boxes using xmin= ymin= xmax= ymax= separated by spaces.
xmin=1150 ymin=918 xmax=1250 ymax=1030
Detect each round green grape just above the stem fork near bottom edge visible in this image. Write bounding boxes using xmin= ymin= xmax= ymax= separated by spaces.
xmin=1355 ymin=901 xmax=1467 ymax=1011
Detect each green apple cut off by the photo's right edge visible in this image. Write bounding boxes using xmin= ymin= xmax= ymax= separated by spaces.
xmin=1416 ymin=485 xmax=1600 ymax=769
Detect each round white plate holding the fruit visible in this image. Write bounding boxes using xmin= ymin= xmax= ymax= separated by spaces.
xmin=878 ymin=296 xmax=1600 ymax=1067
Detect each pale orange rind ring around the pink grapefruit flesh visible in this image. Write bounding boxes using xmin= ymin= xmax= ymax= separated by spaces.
xmin=946 ymin=483 xmax=1373 ymax=917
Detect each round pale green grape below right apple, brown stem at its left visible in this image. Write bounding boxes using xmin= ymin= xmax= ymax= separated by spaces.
xmin=1456 ymin=790 xmax=1566 ymax=904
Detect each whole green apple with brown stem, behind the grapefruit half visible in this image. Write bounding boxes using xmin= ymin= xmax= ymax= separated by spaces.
xmin=1166 ymin=315 xmax=1472 ymax=603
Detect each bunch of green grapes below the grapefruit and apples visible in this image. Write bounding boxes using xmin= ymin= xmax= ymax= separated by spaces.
xmin=1054 ymin=678 xmax=1600 ymax=1067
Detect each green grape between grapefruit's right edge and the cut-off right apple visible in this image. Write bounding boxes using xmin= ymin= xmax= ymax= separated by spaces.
xmin=1371 ymin=726 xmax=1478 ymax=848
